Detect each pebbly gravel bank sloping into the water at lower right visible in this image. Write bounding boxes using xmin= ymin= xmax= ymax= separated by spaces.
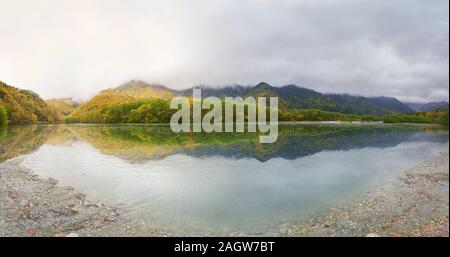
xmin=279 ymin=149 xmax=449 ymax=237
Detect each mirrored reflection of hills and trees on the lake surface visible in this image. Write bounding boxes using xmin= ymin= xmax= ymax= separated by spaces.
xmin=0 ymin=125 xmax=448 ymax=163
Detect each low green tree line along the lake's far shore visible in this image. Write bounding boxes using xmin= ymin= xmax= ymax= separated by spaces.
xmin=66 ymin=99 xmax=448 ymax=124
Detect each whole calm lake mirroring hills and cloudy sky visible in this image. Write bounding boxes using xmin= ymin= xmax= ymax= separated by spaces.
xmin=0 ymin=124 xmax=449 ymax=235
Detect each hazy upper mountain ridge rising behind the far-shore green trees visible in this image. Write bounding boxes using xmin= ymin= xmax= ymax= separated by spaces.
xmin=74 ymin=80 xmax=414 ymax=115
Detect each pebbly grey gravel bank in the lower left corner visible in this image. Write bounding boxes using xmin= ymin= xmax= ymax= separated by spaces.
xmin=0 ymin=157 xmax=167 ymax=237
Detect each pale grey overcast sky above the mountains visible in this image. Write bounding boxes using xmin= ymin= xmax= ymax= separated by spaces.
xmin=0 ymin=0 xmax=449 ymax=101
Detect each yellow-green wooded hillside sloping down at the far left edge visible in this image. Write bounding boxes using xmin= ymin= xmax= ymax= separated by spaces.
xmin=0 ymin=81 xmax=59 ymax=124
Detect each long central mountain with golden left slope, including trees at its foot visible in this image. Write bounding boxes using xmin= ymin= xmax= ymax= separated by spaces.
xmin=66 ymin=80 xmax=422 ymax=123
